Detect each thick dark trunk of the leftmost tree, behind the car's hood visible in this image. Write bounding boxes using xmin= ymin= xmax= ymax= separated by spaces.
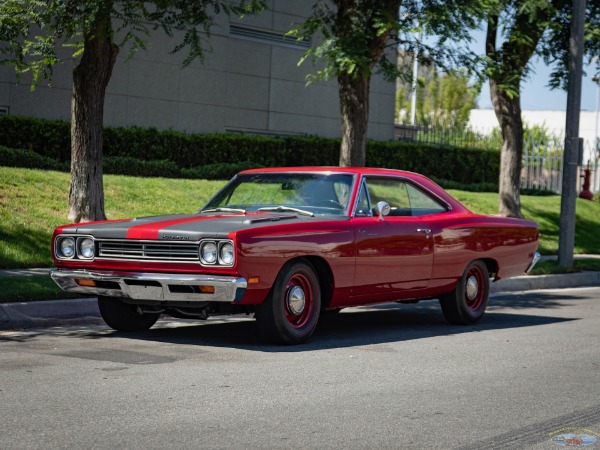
xmin=69 ymin=6 xmax=119 ymax=222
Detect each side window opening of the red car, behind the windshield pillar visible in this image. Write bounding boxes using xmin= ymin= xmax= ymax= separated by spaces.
xmin=367 ymin=177 xmax=446 ymax=217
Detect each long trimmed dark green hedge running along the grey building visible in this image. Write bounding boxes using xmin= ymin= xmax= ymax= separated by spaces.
xmin=0 ymin=115 xmax=500 ymax=185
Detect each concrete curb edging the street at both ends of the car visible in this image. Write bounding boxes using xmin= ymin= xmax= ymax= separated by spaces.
xmin=0 ymin=272 xmax=600 ymax=330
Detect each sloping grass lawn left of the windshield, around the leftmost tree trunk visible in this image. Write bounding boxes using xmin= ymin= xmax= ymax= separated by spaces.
xmin=0 ymin=167 xmax=223 ymax=269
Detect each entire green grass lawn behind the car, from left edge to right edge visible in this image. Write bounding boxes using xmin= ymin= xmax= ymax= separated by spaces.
xmin=0 ymin=167 xmax=600 ymax=268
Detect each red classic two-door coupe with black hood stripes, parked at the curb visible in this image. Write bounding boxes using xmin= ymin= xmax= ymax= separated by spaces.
xmin=52 ymin=167 xmax=539 ymax=344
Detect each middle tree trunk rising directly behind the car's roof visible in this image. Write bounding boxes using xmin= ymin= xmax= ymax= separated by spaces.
xmin=338 ymin=73 xmax=371 ymax=167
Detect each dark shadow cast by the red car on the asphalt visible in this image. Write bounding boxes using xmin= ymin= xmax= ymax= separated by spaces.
xmin=0 ymin=291 xmax=580 ymax=353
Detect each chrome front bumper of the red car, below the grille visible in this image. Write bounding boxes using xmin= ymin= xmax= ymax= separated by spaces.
xmin=50 ymin=269 xmax=247 ymax=303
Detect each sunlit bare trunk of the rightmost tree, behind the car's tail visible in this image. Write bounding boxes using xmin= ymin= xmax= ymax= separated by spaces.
xmin=490 ymin=78 xmax=523 ymax=217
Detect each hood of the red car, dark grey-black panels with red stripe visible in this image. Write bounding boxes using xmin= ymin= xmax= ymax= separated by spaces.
xmin=62 ymin=213 xmax=332 ymax=241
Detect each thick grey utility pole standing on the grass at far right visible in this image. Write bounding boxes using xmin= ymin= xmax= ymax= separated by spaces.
xmin=558 ymin=0 xmax=585 ymax=268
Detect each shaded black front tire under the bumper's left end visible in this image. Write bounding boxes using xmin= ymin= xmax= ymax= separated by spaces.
xmin=98 ymin=295 xmax=160 ymax=331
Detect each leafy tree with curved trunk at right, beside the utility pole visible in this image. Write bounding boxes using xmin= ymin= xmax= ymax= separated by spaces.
xmin=482 ymin=0 xmax=600 ymax=217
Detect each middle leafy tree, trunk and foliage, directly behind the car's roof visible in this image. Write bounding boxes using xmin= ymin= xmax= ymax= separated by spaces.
xmin=290 ymin=0 xmax=481 ymax=166
